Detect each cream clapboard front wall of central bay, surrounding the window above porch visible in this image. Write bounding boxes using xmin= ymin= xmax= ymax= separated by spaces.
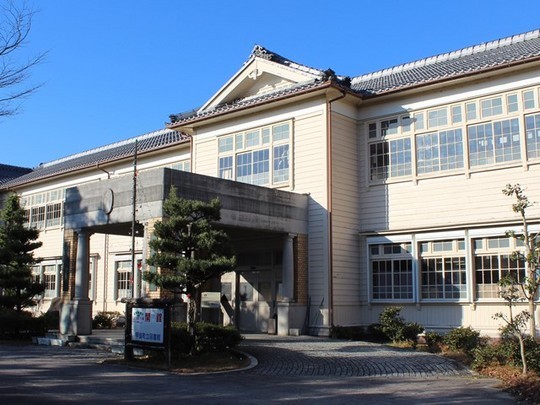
xmin=193 ymin=99 xmax=329 ymax=322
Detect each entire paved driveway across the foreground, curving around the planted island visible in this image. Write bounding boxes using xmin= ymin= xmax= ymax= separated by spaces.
xmin=0 ymin=331 xmax=515 ymax=405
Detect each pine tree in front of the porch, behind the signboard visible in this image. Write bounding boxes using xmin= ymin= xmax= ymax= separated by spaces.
xmin=143 ymin=187 xmax=236 ymax=333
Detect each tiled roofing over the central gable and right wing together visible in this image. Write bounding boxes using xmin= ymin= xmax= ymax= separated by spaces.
xmin=171 ymin=30 xmax=540 ymax=128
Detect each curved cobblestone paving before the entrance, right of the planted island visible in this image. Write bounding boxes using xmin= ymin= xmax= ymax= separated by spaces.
xmin=240 ymin=335 xmax=471 ymax=377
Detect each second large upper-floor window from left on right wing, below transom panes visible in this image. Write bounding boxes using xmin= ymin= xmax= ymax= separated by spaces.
xmin=416 ymin=129 xmax=463 ymax=174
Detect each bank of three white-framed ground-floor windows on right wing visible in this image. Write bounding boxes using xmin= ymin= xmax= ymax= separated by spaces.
xmin=367 ymin=229 xmax=538 ymax=301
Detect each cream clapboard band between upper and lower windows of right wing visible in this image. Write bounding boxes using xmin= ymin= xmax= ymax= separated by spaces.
xmin=361 ymin=165 xmax=540 ymax=232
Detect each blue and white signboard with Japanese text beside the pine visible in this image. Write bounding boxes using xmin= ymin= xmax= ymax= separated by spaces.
xmin=131 ymin=307 xmax=165 ymax=344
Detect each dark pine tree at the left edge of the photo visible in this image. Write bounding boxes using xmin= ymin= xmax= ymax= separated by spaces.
xmin=0 ymin=194 xmax=45 ymax=314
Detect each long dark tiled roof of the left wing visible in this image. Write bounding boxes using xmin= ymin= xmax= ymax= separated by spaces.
xmin=0 ymin=129 xmax=188 ymax=190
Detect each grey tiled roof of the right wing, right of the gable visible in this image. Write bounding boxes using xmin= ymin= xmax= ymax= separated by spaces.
xmin=351 ymin=30 xmax=540 ymax=95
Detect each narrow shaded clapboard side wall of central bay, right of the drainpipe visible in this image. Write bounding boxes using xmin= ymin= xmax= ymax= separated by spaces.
xmin=326 ymin=108 xmax=362 ymax=325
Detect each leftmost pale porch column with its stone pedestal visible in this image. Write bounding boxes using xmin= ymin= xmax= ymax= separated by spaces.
xmin=60 ymin=229 xmax=92 ymax=336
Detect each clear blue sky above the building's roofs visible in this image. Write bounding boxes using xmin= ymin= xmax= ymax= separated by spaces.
xmin=0 ymin=0 xmax=540 ymax=167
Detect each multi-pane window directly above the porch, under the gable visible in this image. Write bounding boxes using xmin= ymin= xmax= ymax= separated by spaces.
xmin=218 ymin=122 xmax=291 ymax=185
